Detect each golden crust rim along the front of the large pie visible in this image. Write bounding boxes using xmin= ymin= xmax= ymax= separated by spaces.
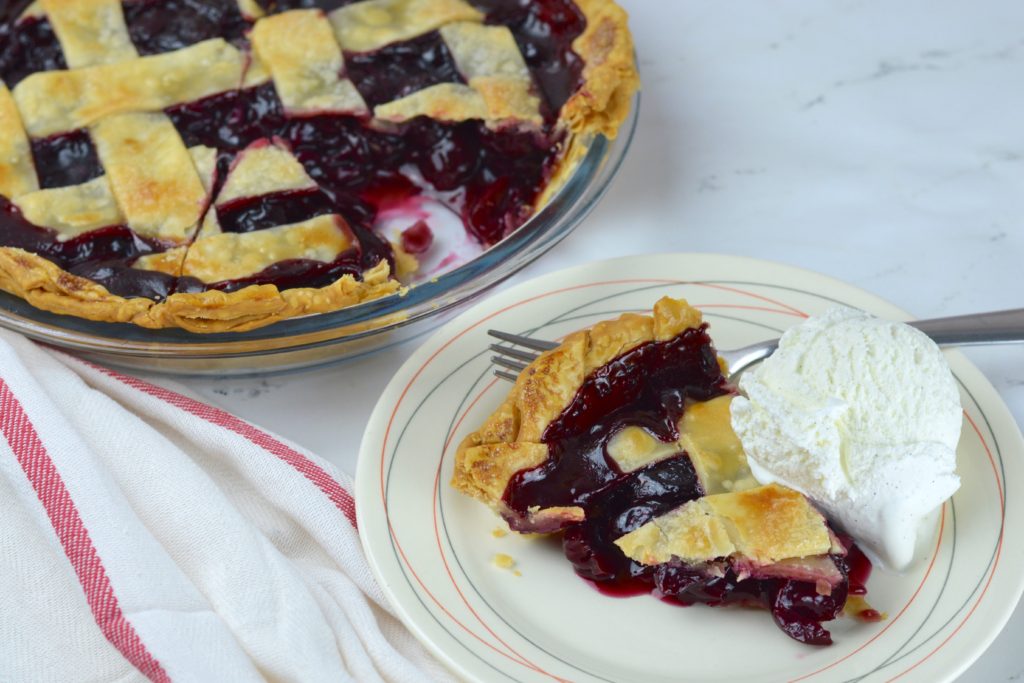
xmin=0 ymin=247 xmax=402 ymax=333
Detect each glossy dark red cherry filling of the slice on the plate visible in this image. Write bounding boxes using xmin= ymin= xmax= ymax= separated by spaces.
xmin=503 ymin=325 xmax=872 ymax=645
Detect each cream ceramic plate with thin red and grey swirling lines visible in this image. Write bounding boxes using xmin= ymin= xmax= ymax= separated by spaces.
xmin=356 ymin=254 xmax=1024 ymax=683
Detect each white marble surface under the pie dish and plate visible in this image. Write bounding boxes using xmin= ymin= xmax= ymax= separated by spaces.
xmin=161 ymin=0 xmax=1024 ymax=683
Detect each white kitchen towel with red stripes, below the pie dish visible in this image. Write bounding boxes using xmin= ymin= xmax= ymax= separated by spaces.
xmin=0 ymin=332 xmax=449 ymax=683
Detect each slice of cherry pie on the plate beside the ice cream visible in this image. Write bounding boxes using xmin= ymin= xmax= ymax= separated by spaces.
xmin=453 ymin=298 xmax=873 ymax=644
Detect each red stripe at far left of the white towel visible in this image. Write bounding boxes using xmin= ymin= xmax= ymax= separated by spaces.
xmin=0 ymin=379 xmax=171 ymax=683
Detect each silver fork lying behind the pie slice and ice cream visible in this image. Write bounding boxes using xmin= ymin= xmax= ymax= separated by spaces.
xmin=487 ymin=308 xmax=1024 ymax=382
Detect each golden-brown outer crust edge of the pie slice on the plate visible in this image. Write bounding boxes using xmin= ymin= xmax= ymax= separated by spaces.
xmin=452 ymin=297 xmax=701 ymax=518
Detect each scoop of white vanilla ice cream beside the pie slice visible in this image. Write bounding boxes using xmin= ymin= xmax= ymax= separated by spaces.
xmin=732 ymin=308 xmax=963 ymax=570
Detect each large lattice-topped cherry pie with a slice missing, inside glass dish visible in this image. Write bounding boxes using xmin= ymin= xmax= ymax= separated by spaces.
xmin=0 ymin=0 xmax=637 ymax=332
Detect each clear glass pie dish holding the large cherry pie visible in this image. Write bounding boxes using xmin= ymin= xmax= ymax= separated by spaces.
xmin=0 ymin=100 xmax=639 ymax=376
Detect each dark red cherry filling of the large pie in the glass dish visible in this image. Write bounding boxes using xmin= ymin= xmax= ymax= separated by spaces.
xmin=0 ymin=0 xmax=585 ymax=301
